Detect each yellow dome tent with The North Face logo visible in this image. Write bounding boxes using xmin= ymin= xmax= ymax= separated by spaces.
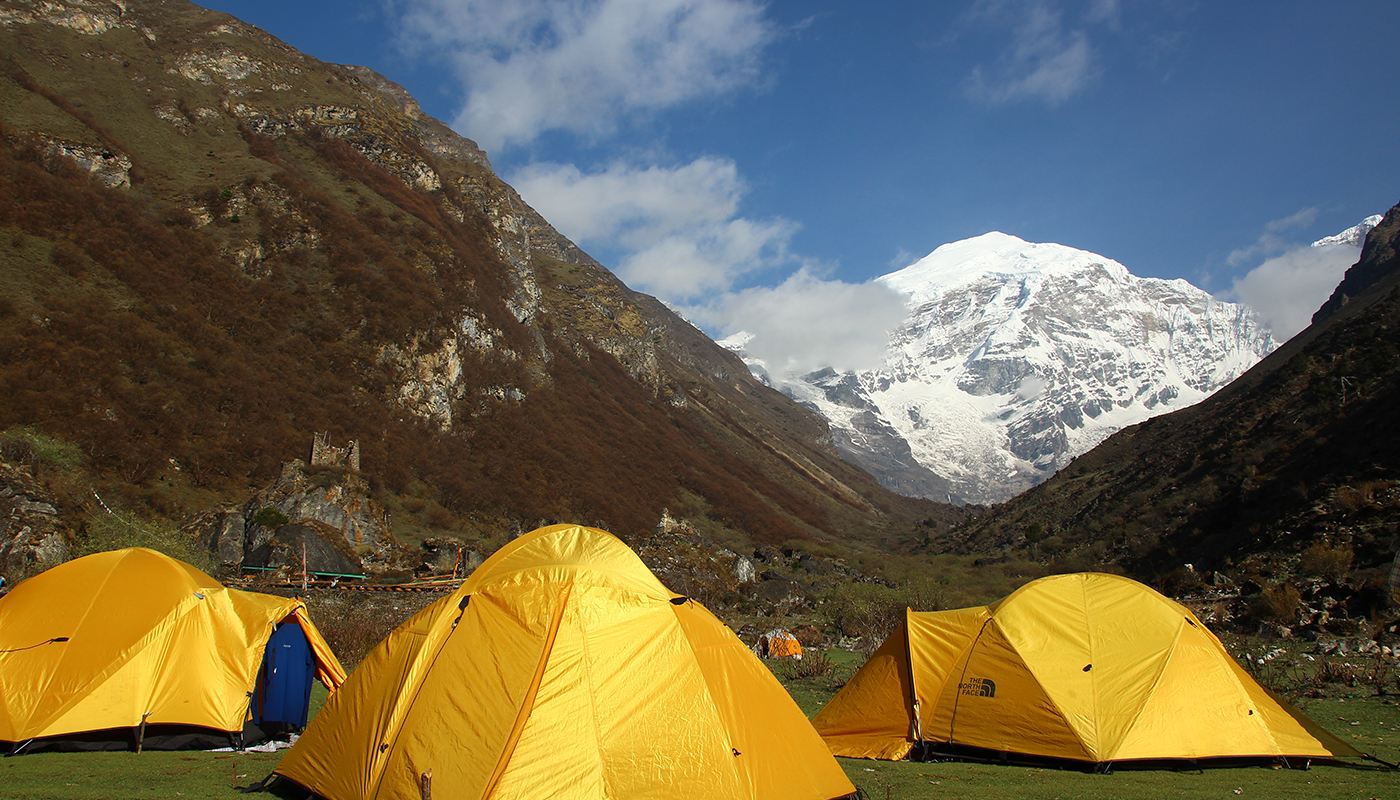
xmin=812 ymin=573 xmax=1361 ymax=764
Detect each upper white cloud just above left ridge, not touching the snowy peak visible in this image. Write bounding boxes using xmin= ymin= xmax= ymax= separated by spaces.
xmin=510 ymin=158 xmax=797 ymax=303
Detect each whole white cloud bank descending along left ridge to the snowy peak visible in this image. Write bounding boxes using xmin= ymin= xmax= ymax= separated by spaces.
xmin=510 ymin=157 xmax=906 ymax=382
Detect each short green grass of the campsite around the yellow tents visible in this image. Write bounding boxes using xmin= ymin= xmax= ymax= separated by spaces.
xmin=0 ymin=643 xmax=1400 ymax=800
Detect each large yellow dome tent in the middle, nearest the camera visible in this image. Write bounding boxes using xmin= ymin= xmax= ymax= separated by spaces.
xmin=276 ymin=525 xmax=855 ymax=800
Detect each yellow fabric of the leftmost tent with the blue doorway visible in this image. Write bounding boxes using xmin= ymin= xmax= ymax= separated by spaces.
xmin=0 ymin=548 xmax=346 ymax=743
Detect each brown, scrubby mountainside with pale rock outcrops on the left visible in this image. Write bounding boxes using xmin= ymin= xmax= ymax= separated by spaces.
xmin=0 ymin=0 xmax=956 ymax=568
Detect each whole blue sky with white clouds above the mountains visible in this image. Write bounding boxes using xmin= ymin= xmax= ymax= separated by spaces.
xmin=203 ymin=0 xmax=1400 ymax=378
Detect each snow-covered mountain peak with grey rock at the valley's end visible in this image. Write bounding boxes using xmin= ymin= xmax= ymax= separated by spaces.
xmin=744 ymin=233 xmax=1277 ymax=503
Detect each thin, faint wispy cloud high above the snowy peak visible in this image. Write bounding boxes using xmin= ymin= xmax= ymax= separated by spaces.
xmin=966 ymin=0 xmax=1117 ymax=105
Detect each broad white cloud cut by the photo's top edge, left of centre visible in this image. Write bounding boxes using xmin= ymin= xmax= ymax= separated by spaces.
xmin=398 ymin=0 xmax=774 ymax=151
